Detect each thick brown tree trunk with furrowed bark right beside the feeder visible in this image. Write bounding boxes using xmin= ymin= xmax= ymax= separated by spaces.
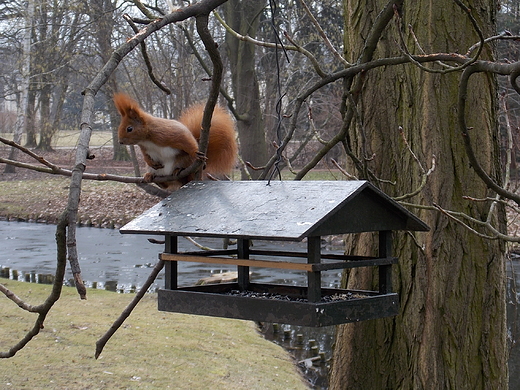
xmin=330 ymin=0 xmax=507 ymax=390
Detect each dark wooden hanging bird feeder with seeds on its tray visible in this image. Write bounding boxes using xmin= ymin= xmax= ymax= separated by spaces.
xmin=120 ymin=181 xmax=428 ymax=327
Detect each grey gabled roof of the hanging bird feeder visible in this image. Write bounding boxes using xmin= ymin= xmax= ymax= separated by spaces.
xmin=120 ymin=181 xmax=429 ymax=241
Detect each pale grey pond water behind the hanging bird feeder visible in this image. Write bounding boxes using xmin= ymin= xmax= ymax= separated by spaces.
xmin=0 ymin=221 xmax=341 ymax=292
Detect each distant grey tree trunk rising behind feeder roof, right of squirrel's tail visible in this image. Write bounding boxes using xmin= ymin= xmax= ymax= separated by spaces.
xmin=224 ymin=0 xmax=267 ymax=179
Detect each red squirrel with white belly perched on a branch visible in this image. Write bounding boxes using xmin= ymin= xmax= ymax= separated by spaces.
xmin=114 ymin=93 xmax=238 ymax=190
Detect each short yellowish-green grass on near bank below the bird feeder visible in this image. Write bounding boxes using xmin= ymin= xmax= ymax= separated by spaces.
xmin=0 ymin=279 xmax=307 ymax=390
